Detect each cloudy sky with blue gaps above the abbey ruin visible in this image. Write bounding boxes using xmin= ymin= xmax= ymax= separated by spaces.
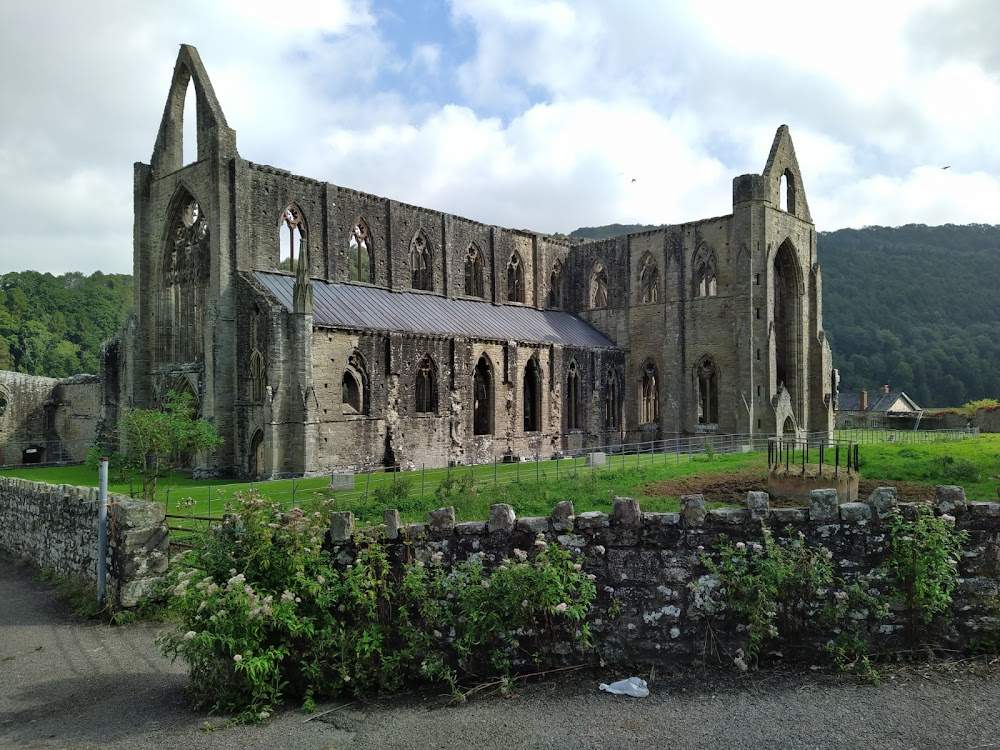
xmin=0 ymin=0 xmax=1000 ymax=273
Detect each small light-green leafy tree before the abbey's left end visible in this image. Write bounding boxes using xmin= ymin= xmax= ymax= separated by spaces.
xmin=88 ymin=391 xmax=224 ymax=501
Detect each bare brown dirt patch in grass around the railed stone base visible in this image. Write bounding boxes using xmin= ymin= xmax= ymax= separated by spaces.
xmin=642 ymin=468 xmax=934 ymax=508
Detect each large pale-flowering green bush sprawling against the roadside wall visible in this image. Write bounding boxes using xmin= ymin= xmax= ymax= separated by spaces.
xmin=161 ymin=493 xmax=595 ymax=722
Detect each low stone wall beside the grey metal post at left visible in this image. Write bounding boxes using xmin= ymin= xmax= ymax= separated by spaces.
xmin=0 ymin=477 xmax=170 ymax=607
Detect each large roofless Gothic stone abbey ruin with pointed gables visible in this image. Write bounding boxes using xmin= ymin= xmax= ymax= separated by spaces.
xmin=3 ymin=46 xmax=837 ymax=477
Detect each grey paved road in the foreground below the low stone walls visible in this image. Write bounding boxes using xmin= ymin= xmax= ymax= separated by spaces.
xmin=0 ymin=559 xmax=1000 ymax=750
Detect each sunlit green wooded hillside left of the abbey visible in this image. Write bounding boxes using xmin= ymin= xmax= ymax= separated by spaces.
xmin=0 ymin=271 xmax=132 ymax=378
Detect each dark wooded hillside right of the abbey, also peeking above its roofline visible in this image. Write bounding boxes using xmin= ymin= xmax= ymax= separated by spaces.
xmin=570 ymin=224 xmax=1000 ymax=407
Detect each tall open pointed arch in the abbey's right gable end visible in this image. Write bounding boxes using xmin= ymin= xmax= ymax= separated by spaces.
xmin=772 ymin=239 xmax=805 ymax=422
